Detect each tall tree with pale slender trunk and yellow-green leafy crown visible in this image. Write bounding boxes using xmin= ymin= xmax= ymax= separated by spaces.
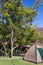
xmin=2 ymin=0 xmax=42 ymax=57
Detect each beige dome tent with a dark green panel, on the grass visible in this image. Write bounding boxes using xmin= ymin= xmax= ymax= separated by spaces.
xmin=24 ymin=42 xmax=43 ymax=63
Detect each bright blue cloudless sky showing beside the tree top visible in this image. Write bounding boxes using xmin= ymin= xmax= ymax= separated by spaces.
xmin=0 ymin=0 xmax=43 ymax=27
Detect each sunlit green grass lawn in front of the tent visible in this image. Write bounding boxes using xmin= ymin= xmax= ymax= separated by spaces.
xmin=0 ymin=57 xmax=43 ymax=65
